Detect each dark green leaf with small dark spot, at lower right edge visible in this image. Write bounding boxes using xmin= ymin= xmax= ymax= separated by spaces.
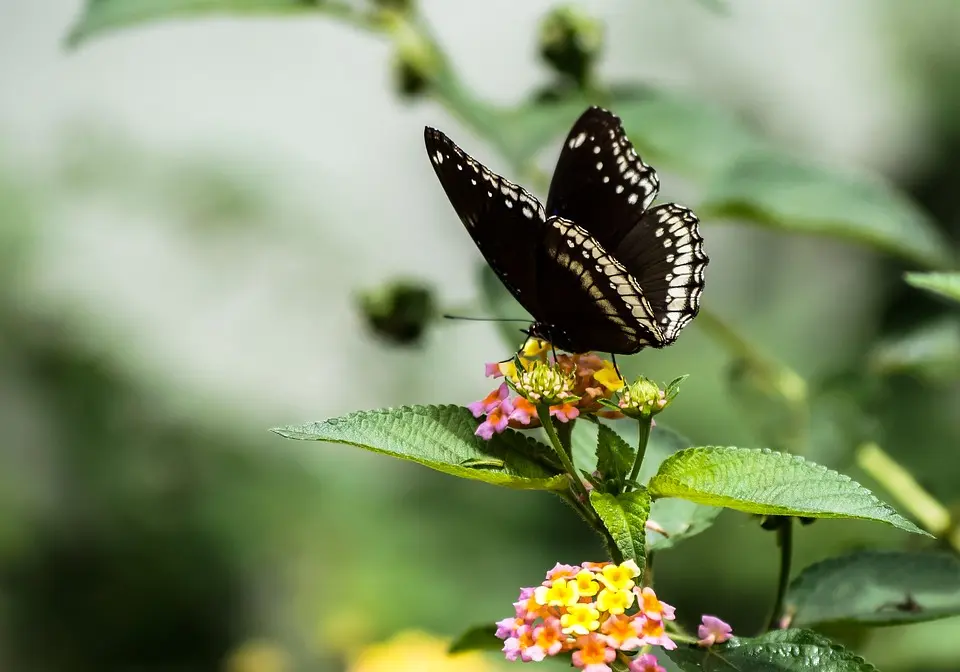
xmin=786 ymin=551 xmax=960 ymax=627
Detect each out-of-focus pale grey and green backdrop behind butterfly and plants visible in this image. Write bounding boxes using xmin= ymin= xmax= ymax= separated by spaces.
xmin=0 ymin=0 xmax=960 ymax=672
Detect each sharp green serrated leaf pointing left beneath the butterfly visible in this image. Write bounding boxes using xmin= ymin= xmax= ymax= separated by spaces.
xmin=273 ymin=406 xmax=568 ymax=490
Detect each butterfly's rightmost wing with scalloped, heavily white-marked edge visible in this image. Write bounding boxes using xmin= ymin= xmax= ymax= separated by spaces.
xmin=614 ymin=203 xmax=709 ymax=346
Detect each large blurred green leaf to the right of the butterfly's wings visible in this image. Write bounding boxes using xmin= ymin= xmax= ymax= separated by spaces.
xmin=697 ymin=152 xmax=953 ymax=268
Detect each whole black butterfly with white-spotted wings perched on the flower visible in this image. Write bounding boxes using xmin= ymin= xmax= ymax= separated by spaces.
xmin=424 ymin=107 xmax=708 ymax=354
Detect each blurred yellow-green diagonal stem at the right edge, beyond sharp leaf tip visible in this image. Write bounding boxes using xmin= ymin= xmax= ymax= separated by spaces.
xmin=856 ymin=442 xmax=960 ymax=551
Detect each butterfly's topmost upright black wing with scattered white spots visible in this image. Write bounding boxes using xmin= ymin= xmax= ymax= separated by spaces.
xmin=547 ymin=107 xmax=660 ymax=249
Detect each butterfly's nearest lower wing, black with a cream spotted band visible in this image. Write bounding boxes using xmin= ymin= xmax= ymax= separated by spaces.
xmin=537 ymin=217 xmax=663 ymax=353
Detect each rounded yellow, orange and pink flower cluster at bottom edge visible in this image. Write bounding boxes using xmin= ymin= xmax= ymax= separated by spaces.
xmin=496 ymin=560 xmax=677 ymax=672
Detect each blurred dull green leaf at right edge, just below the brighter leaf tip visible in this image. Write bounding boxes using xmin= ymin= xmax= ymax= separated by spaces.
xmin=869 ymin=318 xmax=960 ymax=382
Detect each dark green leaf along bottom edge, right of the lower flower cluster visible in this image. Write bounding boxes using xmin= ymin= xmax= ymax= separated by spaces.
xmin=667 ymin=630 xmax=877 ymax=672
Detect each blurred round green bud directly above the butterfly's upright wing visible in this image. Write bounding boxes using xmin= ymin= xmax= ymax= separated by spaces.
xmin=540 ymin=6 xmax=603 ymax=89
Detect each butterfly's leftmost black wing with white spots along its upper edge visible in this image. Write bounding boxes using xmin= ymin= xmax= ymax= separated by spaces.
xmin=424 ymin=128 xmax=545 ymax=316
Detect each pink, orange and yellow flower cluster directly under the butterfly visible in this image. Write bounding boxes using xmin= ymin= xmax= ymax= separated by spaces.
xmin=467 ymin=339 xmax=624 ymax=440
